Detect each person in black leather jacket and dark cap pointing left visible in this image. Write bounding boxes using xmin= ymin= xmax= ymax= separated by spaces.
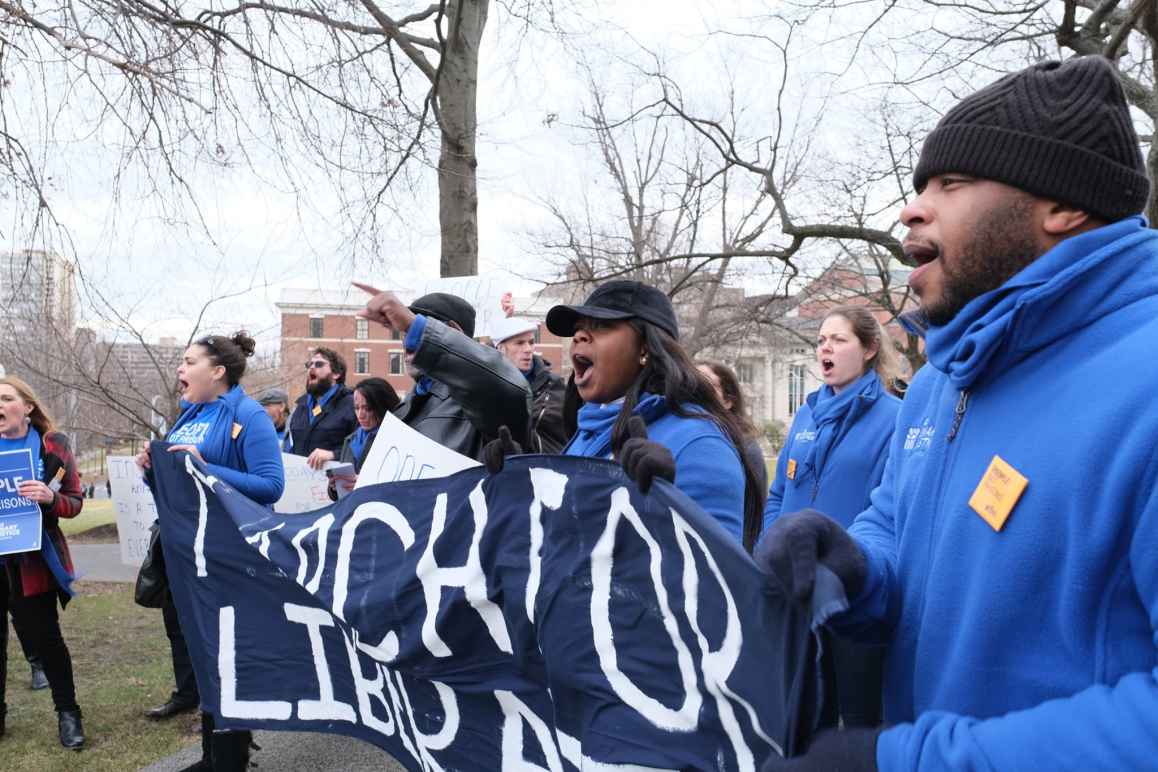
xmin=354 ymin=284 xmax=530 ymax=458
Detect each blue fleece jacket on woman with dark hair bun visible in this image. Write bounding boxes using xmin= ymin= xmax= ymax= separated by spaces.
xmin=169 ymin=385 xmax=286 ymax=506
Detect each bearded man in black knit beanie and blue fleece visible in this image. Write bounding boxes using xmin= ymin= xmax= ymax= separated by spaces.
xmin=756 ymin=57 xmax=1158 ymax=770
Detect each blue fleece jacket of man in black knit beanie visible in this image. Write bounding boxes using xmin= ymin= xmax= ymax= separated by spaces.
xmin=835 ymin=218 xmax=1158 ymax=770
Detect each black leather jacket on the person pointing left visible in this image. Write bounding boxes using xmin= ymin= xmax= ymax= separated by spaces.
xmin=394 ymin=317 xmax=530 ymax=458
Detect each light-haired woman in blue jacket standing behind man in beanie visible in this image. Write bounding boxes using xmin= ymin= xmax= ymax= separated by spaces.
xmin=764 ymin=306 xmax=901 ymax=727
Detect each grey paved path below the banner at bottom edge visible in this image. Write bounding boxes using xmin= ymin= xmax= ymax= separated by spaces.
xmin=144 ymin=731 xmax=405 ymax=772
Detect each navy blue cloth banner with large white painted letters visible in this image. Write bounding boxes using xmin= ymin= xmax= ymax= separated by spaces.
xmin=152 ymin=444 xmax=833 ymax=772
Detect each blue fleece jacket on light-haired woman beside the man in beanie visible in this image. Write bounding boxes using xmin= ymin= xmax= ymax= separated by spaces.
xmin=764 ymin=370 xmax=901 ymax=530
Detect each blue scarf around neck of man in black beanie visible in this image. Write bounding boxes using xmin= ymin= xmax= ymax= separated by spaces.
xmin=925 ymin=216 xmax=1156 ymax=389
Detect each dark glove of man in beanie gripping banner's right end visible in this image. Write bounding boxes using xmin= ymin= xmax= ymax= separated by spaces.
xmin=753 ymin=509 xmax=869 ymax=603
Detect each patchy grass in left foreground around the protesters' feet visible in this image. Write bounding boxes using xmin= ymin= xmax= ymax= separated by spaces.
xmin=0 ymin=583 xmax=200 ymax=772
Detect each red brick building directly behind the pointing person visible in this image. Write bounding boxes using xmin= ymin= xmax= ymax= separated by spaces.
xmin=277 ymin=289 xmax=564 ymax=399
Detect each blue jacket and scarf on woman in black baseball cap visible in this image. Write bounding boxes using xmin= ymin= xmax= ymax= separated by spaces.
xmin=563 ymin=394 xmax=745 ymax=543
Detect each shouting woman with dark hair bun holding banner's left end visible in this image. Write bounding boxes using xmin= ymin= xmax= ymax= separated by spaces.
xmin=137 ymin=332 xmax=285 ymax=772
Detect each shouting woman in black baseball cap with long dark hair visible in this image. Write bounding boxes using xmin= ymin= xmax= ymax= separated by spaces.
xmin=547 ymin=280 xmax=764 ymax=550
